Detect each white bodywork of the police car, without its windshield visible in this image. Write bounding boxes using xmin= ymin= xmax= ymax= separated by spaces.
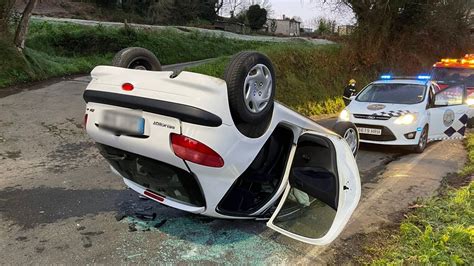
xmin=338 ymin=78 xmax=468 ymax=146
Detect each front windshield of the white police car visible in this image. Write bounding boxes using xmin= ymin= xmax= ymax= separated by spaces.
xmin=356 ymin=83 xmax=426 ymax=104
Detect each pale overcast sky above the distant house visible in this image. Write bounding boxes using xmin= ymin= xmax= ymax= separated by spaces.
xmin=264 ymin=0 xmax=355 ymax=27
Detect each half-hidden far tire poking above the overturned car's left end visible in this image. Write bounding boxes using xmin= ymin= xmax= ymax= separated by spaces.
xmin=112 ymin=47 xmax=161 ymax=71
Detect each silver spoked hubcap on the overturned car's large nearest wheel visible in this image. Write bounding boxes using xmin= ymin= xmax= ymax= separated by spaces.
xmin=244 ymin=64 xmax=273 ymax=114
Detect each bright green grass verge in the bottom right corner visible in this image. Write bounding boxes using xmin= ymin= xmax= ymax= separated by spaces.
xmin=366 ymin=134 xmax=474 ymax=265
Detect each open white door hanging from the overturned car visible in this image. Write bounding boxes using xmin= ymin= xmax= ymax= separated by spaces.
xmin=267 ymin=132 xmax=361 ymax=245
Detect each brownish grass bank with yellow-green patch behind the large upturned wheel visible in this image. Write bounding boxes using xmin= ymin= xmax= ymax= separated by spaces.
xmin=188 ymin=44 xmax=374 ymax=116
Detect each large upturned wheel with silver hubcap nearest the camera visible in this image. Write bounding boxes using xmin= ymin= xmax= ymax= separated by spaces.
xmin=224 ymin=52 xmax=276 ymax=125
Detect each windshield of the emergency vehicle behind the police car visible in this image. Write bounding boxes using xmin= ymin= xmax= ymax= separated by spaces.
xmin=433 ymin=67 xmax=474 ymax=87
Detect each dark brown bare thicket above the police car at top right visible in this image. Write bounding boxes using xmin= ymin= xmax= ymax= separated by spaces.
xmin=312 ymin=0 xmax=473 ymax=71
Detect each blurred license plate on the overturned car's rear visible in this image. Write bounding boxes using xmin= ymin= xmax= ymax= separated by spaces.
xmin=99 ymin=110 xmax=145 ymax=135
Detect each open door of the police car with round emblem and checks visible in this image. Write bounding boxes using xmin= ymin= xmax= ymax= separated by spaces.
xmin=428 ymin=84 xmax=468 ymax=140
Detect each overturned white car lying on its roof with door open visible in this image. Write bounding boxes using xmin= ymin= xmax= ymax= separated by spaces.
xmin=84 ymin=48 xmax=361 ymax=245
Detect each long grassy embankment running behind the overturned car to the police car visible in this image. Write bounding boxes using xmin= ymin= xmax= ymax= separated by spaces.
xmin=0 ymin=22 xmax=373 ymax=115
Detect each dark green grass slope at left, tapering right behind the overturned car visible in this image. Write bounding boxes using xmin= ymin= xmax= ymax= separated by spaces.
xmin=0 ymin=21 xmax=277 ymax=88
